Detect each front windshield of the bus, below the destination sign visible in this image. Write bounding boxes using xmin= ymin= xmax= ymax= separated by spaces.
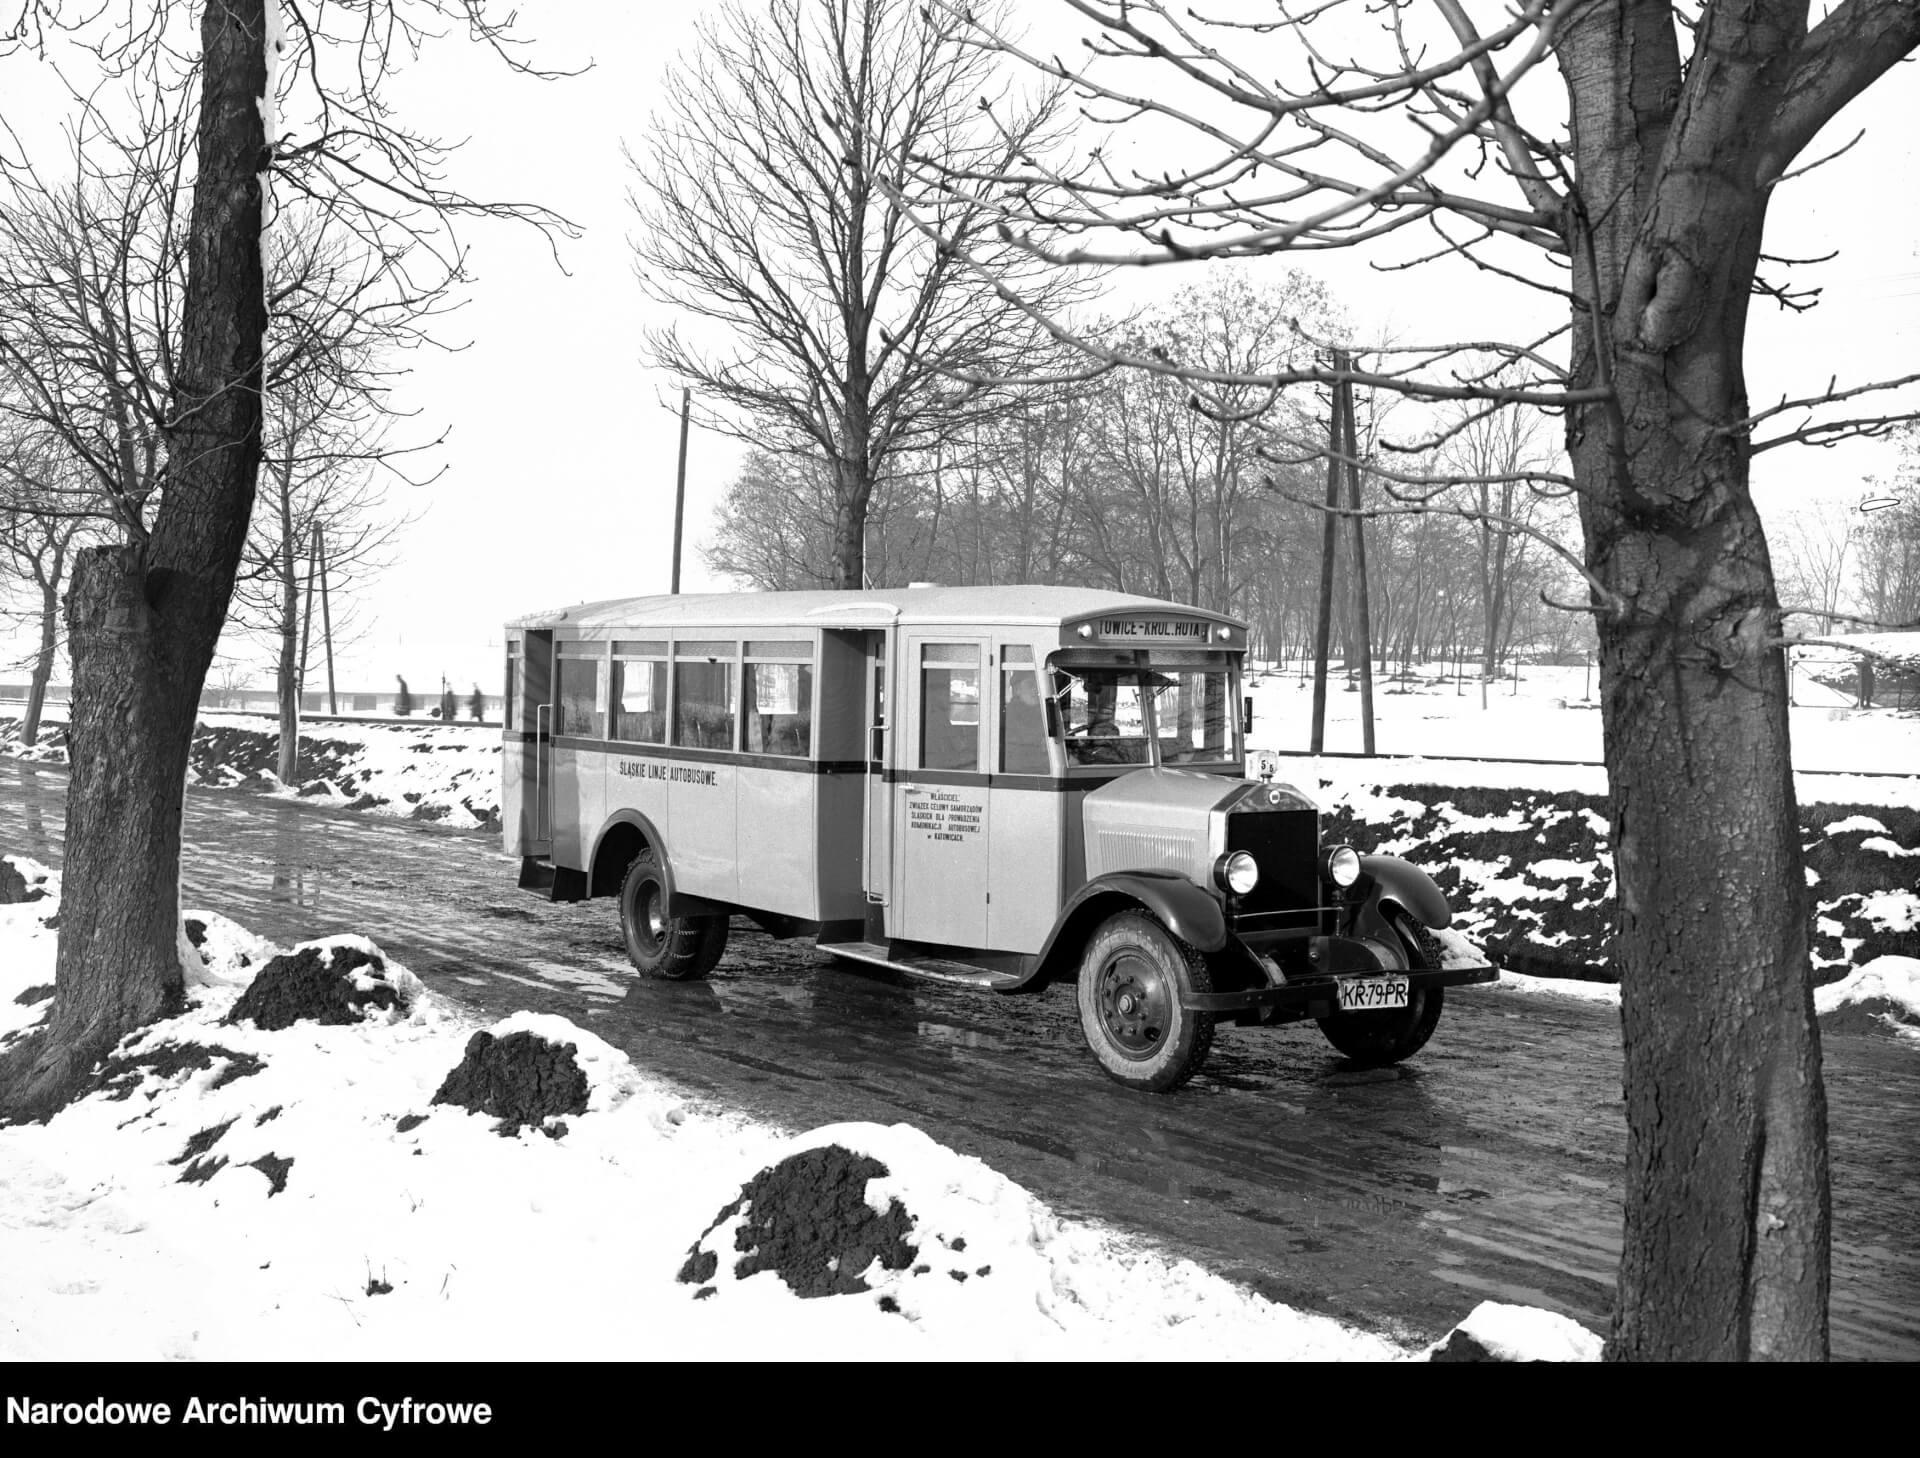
xmin=1054 ymin=667 xmax=1233 ymax=765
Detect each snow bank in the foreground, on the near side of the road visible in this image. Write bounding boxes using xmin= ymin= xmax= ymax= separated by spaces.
xmin=0 ymin=859 xmax=1599 ymax=1364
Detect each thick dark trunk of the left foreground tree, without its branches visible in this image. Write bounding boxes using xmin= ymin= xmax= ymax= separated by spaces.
xmin=0 ymin=0 xmax=267 ymax=1116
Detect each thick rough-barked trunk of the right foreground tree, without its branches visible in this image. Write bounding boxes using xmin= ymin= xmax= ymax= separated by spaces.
xmin=1561 ymin=6 xmax=1830 ymax=1360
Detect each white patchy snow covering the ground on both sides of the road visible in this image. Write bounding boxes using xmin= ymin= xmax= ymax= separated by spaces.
xmin=0 ymin=653 xmax=1920 ymax=1362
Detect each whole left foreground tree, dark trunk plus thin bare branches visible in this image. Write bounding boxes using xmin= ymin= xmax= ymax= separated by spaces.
xmin=0 ymin=0 xmax=570 ymax=1116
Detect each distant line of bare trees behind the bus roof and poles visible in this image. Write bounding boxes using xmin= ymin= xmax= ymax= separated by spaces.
xmin=705 ymin=273 xmax=1588 ymax=670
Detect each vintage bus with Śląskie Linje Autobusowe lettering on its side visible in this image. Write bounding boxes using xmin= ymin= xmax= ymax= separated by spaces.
xmin=501 ymin=586 xmax=1496 ymax=1091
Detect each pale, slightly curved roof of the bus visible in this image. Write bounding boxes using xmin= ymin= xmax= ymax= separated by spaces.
xmin=507 ymin=584 xmax=1246 ymax=630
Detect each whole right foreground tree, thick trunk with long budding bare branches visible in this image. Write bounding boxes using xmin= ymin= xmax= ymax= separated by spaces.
xmin=910 ymin=0 xmax=1920 ymax=1360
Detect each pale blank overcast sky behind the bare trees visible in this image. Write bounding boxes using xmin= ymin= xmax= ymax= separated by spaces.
xmin=10 ymin=0 xmax=1920 ymax=692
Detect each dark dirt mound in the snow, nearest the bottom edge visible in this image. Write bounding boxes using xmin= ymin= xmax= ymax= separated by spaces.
xmin=680 ymin=1145 xmax=920 ymax=1297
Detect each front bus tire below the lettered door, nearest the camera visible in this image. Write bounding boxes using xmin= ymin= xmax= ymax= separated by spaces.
xmin=1075 ymin=909 xmax=1213 ymax=1093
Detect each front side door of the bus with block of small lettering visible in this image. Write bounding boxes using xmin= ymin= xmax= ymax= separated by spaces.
xmin=887 ymin=634 xmax=989 ymax=947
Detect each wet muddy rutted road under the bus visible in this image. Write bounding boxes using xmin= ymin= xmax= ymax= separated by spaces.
xmin=0 ymin=761 xmax=1920 ymax=1360
